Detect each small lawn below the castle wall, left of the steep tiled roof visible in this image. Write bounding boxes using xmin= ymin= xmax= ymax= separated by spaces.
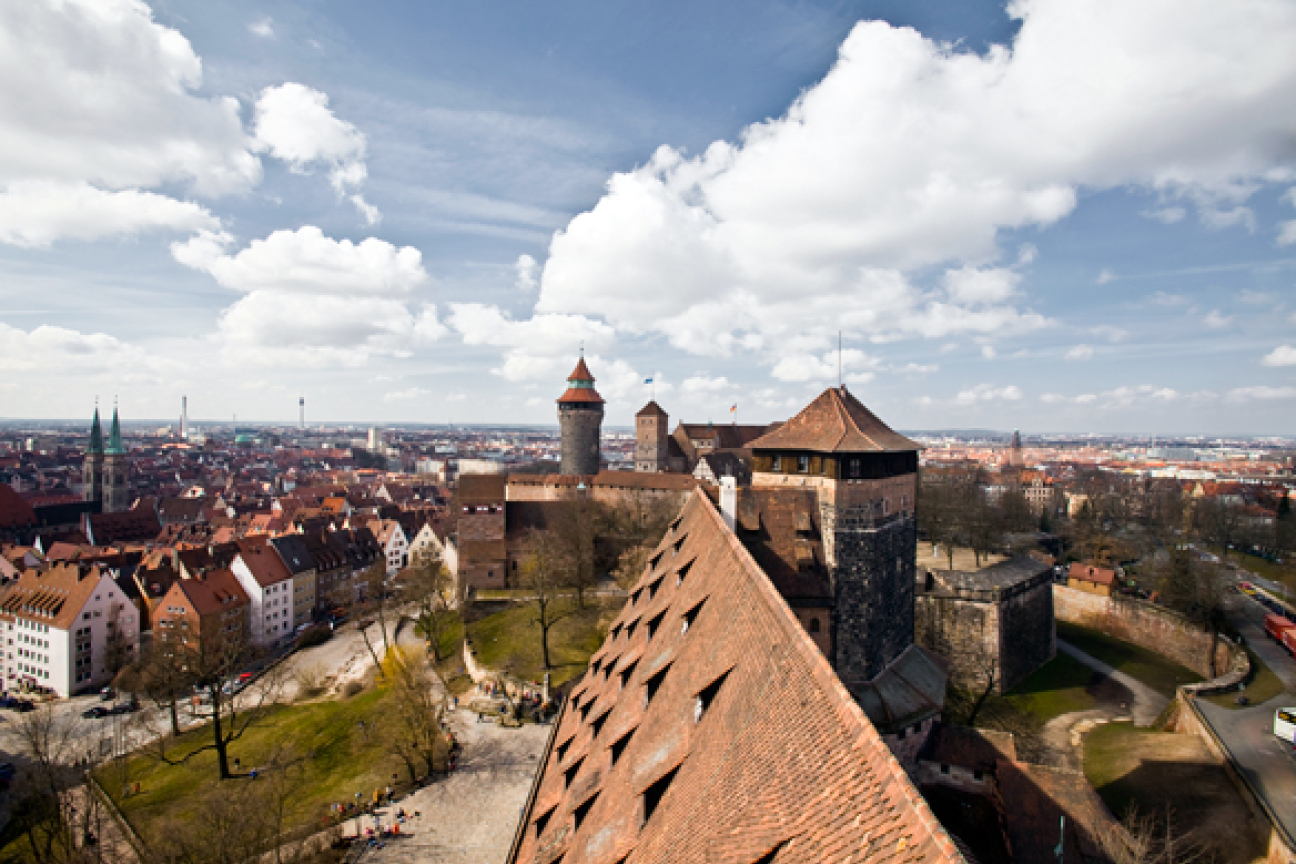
xmin=468 ymin=598 xmax=611 ymax=687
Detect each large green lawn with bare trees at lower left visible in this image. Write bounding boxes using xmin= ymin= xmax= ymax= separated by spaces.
xmin=98 ymin=687 xmax=435 ymax=843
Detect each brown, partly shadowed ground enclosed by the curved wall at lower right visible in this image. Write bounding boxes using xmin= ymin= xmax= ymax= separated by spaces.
xmin=1085 ymin=723 xmax=1265 ymax=864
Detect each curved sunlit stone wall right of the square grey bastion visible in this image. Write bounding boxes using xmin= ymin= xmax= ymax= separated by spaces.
xmin=1052 ymin=584 xmax=1232 ymax=679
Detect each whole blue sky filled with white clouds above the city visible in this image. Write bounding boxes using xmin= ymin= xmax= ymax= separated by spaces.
xmin=0 ymin=0 xmax=1296 ymax=435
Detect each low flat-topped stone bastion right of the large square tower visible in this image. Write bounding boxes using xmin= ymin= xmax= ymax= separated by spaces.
xmin=915 ymin=556 xmax=1058 ymax=693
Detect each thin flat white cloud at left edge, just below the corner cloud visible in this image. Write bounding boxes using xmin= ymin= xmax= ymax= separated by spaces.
xmin=0 ymin=181 xmax=220 ymax=247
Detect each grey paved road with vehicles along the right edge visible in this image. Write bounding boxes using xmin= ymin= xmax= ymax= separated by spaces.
xmin=1198 ymin=595 xmax=1296 ymax=838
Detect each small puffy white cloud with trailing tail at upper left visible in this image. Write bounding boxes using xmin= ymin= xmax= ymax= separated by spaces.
xmin=253 ymin=82 xmax=380 ymax=225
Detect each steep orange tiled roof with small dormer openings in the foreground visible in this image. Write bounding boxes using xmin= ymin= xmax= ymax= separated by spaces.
xmin=509 ymin=494 xmax=963 ymax=864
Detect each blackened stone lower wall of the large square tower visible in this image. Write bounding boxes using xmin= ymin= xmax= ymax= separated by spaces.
xmin=824 ymin=508 xmax=918 ymax=681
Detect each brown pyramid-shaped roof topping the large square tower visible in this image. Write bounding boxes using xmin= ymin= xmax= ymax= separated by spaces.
xmin=749 ymin=387 xmax=919 ymax=453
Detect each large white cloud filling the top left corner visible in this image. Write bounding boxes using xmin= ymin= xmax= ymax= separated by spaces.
xmin=0 ymin=0 xmax=260 ymax=196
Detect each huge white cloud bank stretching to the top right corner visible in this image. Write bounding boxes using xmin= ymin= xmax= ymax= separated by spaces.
xmin=523 ymin=0 xmax=1296 ymax=363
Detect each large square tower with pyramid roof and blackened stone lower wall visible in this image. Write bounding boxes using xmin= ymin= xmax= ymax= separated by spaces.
xmin=750 ymin=387 xmax=918 ymax=687
